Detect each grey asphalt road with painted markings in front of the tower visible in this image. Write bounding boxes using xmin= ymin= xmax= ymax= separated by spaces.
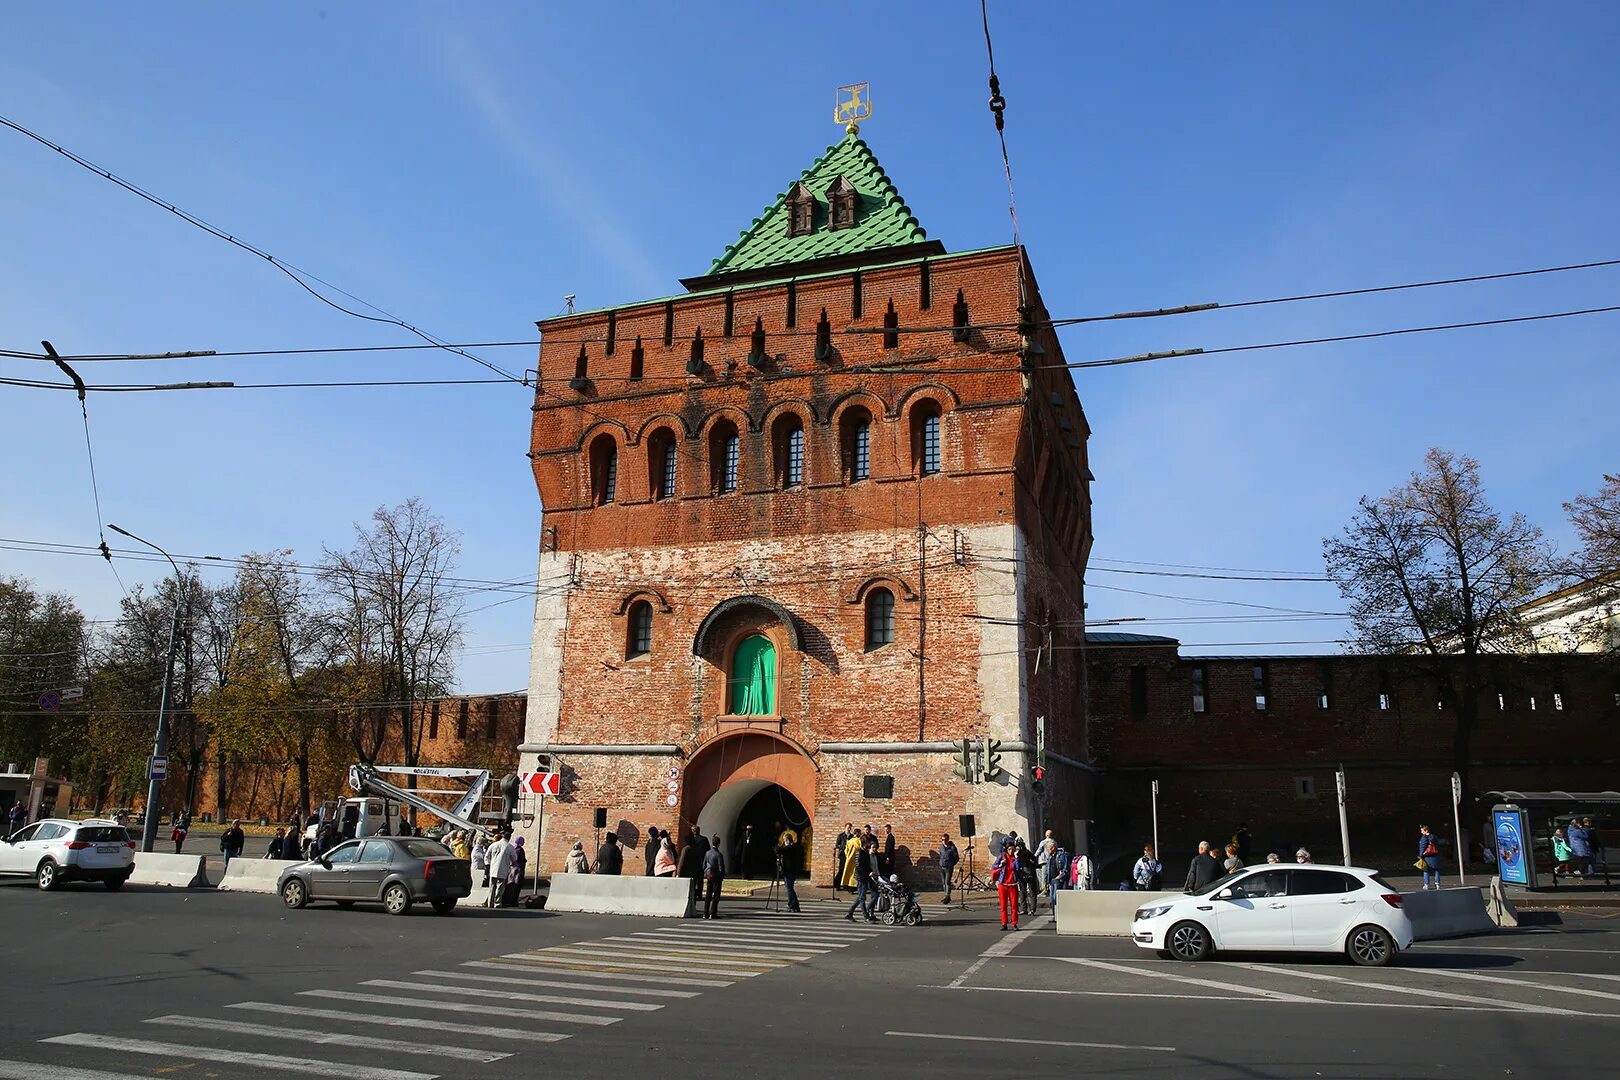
xmin=0 ymin=882 xmax=1620 ymax=1080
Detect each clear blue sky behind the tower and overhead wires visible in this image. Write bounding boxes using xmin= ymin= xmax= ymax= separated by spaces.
xmin=0 ymin=0 xmax=1620 ymax=691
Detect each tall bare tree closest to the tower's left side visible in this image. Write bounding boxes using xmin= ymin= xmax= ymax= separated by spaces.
xmin=322 ymin=499 xmax=462 ymax=764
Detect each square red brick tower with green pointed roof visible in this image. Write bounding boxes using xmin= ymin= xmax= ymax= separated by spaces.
xmin=522 ymin=131 xmax=1092 ymax=882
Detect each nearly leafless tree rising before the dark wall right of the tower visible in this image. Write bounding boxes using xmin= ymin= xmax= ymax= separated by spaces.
xmin=1322 ymin=449 xmax=1550 ymax=798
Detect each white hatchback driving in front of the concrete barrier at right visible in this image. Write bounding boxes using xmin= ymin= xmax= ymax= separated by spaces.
xmin=1131 ymin=865 xmax=1413 ymax=967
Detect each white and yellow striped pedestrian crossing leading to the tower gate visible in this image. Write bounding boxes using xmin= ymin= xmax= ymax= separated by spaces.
xmin=9 ymin=900 xmax=894 ymax=1080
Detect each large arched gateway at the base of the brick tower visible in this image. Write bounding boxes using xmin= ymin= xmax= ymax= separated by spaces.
xmin=680 ymin=729 xmax=816 ymax=878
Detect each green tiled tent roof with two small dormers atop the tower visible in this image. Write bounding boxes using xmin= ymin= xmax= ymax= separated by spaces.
xmin=684 ymin=133 xmax=944 ymax=288
